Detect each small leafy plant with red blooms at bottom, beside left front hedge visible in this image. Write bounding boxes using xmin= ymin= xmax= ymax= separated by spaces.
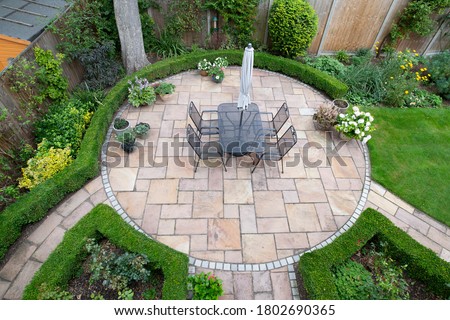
xmin=188 ymin=272 xmax=223 ymax=300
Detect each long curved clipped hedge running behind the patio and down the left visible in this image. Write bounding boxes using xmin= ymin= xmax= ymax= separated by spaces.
xmin=0 ymin=50 xmax=348 ymax=260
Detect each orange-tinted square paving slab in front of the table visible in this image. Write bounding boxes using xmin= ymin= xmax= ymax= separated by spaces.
xmin=208 ymin=219 xmax=241 ymax=250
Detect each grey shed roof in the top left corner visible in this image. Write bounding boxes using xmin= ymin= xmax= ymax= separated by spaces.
xmin=0 ymin=0 xmax=68 ymax=41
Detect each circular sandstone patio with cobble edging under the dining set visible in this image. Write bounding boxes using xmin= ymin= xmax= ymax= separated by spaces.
xmin=102 ymin=67 xmax=370 ymax=271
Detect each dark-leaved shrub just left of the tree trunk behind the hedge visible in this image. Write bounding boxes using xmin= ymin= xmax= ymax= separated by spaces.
xmin=76 ymin=41 xmax=123 ymax=90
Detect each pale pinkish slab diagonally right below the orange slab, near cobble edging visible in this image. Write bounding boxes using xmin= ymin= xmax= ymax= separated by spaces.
xmin=242 ymin=234 xmax=277 ymax=263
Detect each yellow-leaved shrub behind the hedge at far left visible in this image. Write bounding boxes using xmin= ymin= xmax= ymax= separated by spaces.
xmin=19 ymin=140 xmax=73 ymax=189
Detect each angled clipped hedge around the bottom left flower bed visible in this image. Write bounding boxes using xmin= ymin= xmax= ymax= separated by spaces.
xmin=23 ymin=204 xmax=189 ymax=300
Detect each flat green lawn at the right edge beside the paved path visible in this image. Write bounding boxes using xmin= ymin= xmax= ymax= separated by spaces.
xmin=368 ymin=108 xmax=450 ymax=226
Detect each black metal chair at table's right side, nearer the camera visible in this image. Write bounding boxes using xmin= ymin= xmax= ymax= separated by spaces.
xmin=251 ymin=126 xmax=297 ymax=173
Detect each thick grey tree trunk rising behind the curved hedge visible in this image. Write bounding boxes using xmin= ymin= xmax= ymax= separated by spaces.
xmin=114 ymin=0 xmax=150 ymax=74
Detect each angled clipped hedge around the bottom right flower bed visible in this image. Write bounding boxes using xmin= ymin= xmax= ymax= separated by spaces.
xmin=298 ymin=209 xmax=450 ymax=300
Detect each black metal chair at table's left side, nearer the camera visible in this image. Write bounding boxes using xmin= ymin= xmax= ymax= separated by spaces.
xmin=186 ymin=124 xmax=227 ymax=172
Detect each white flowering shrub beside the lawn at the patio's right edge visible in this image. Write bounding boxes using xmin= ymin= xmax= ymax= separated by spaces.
xmin=335 ymin=107 xmax=375 ymax=143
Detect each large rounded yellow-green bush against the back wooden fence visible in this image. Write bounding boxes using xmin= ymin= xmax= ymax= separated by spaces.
xmin=269 ymin=0 xmax=318 ymax=57
